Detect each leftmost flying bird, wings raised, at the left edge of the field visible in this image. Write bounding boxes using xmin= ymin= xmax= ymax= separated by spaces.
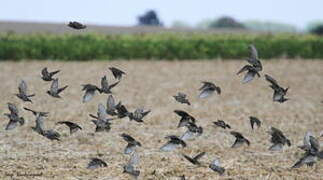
xmin=4 ymin=103 xmax=25 ymax=130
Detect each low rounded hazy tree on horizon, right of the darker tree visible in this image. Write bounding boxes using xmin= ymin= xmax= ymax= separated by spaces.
xmin=210 ymin=16 xmax=245 ymax=29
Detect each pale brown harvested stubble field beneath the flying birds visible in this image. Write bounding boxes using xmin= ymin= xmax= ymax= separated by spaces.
xmin=0 ymin=60 xmax=323 ymax=180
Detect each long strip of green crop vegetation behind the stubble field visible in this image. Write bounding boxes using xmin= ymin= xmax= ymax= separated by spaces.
xmin=0 ymin=33 xmax=323 ymax=60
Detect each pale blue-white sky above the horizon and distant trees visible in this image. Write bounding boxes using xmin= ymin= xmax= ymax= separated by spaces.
xmin=0 ymin=0 xmax=323 ymax=28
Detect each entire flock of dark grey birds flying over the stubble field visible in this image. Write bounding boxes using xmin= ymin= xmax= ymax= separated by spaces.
xmin=5 ymin=22 xmax=323 ymax=180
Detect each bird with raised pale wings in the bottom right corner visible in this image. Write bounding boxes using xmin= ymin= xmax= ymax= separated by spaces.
xmin=292 ymin=132 xmax=323 ymax=168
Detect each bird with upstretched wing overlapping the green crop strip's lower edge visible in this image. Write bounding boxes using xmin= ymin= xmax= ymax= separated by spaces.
xmin=237 ymin=44 xmax=262 ymax=83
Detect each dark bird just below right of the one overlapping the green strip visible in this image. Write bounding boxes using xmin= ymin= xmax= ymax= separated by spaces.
xmin=265 ymin=74 xmax=289 ymax=103
